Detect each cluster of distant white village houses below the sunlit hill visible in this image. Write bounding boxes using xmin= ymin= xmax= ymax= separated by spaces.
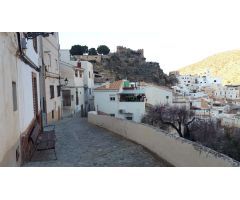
xmin=170 ymin=69 xmax=240 ymax=128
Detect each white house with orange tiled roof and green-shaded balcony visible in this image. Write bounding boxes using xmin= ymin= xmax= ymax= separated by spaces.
xmin=94 ymin=80 xmax=145 ymax=122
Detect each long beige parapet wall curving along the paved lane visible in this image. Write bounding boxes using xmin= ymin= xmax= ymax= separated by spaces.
xmin=88 ymin=111 xmax=240 ymax=167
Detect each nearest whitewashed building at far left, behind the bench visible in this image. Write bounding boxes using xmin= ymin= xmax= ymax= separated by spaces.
xmin=0 ymin=33 xmax=41 ymax=166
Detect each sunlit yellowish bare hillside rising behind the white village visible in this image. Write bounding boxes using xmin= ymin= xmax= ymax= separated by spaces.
xmin=178 ymin=50 xmax=240 ymax=84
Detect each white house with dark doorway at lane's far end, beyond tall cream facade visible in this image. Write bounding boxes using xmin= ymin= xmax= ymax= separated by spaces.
xmin=60 ymin=61 xmax=84 ymax=117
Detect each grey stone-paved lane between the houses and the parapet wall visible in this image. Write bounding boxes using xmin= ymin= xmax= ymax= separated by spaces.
xmin=24 ymin=117 xmax=168 ymax=167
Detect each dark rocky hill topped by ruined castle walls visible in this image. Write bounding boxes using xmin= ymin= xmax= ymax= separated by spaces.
xmin=90 ymin=47 xmax=175 ymax=86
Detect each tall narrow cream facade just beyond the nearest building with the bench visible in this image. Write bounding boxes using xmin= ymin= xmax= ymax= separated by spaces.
xmin=41 ymin=33 xmax=62 ymax=124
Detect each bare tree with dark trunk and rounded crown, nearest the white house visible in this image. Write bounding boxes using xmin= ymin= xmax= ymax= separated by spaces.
xmin=142 ymin=105 xmax=195 ymax=138
